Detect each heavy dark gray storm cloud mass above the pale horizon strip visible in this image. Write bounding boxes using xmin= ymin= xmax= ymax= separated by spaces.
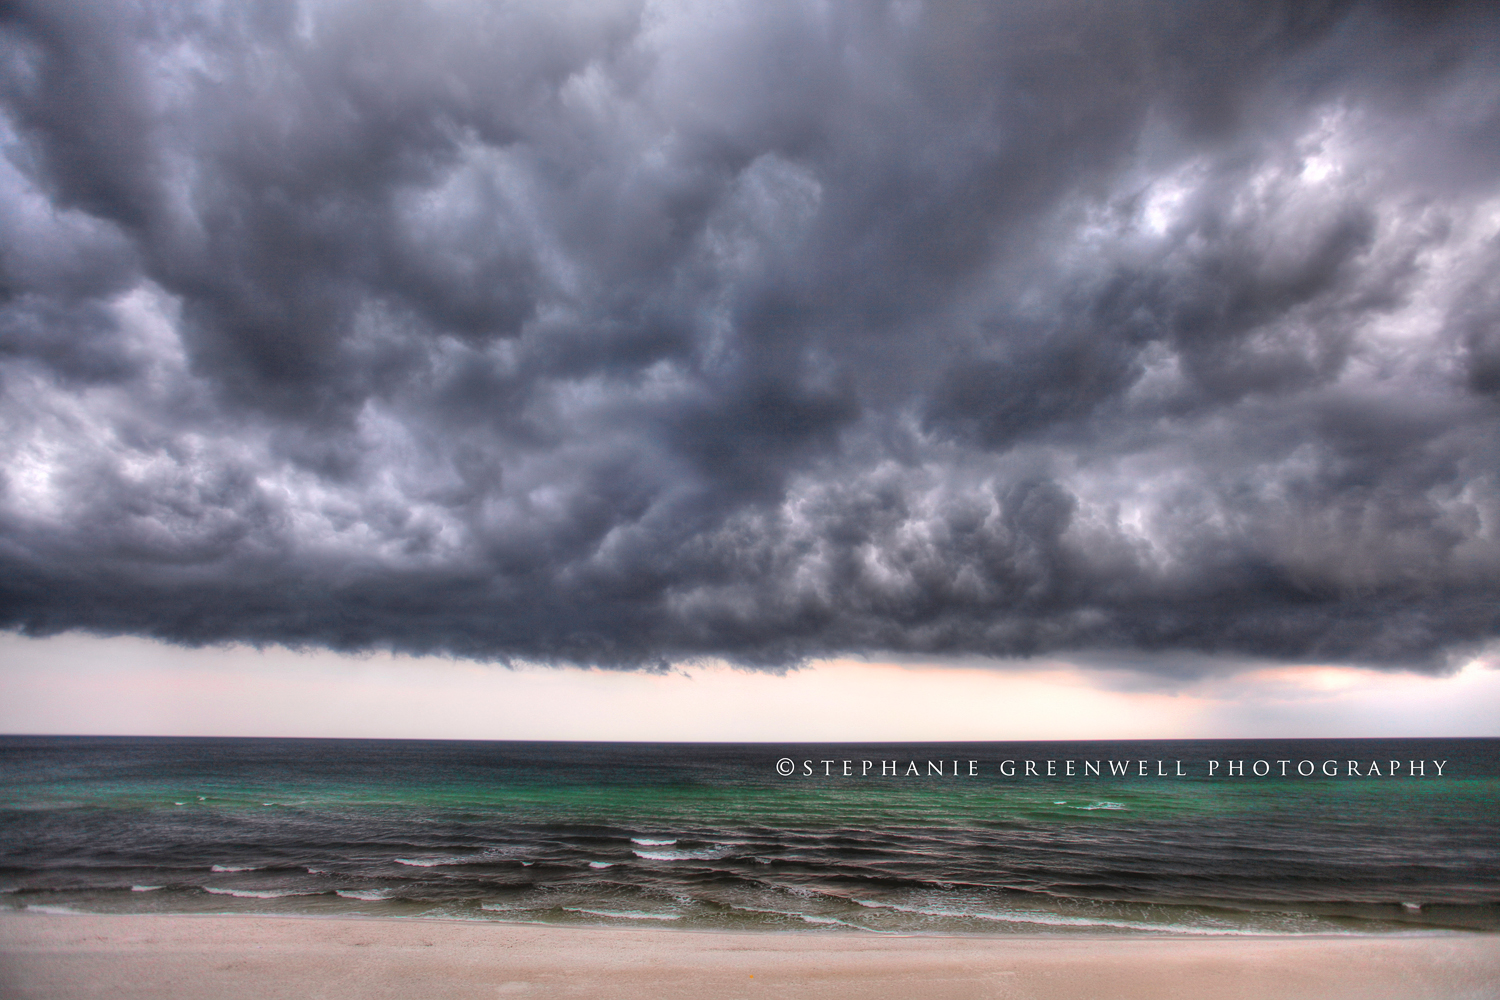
xmin=0 ymin=0 xmax=1500 ymax=670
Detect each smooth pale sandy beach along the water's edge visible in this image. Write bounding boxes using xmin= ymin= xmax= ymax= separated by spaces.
xmin=0 ymin=913 xmax=1500 ymax=1000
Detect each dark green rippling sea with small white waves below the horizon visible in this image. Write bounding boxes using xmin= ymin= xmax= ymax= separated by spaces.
xmin=0 ymin=736 xmax=1500 ymax=934
